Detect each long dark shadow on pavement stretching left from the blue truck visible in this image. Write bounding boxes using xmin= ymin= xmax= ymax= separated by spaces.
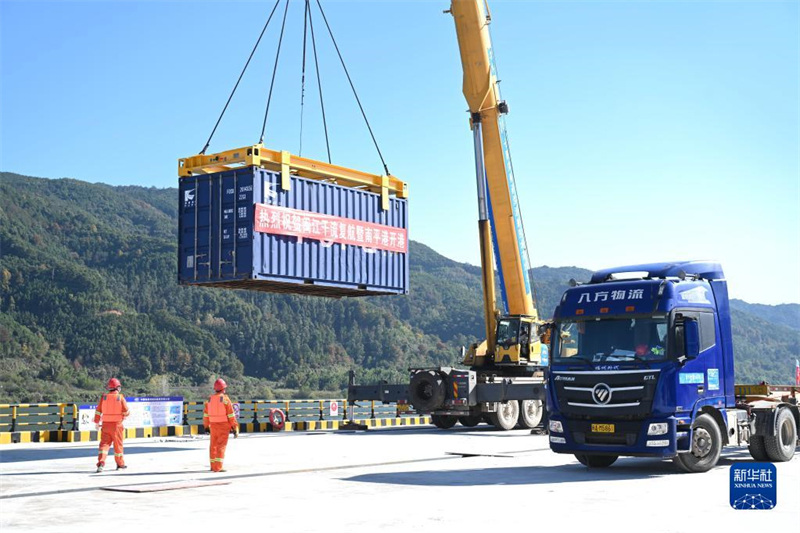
xmin=344 ymin=458 xmax=677 ymax=487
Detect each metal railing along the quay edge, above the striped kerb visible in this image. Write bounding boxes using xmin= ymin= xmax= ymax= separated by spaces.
xmin=0 ymin=398 xmax=422 ymax=433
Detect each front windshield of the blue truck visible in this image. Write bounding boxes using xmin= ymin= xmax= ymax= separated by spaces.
xmin=555 ymin=317 xmax=667 ymax=363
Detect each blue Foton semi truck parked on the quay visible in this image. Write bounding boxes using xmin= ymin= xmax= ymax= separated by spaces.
xmin=546 ymin=261 xmax=800 ymax=472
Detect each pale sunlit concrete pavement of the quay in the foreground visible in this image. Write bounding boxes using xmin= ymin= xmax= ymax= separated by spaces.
xmin=0 ymin=426 xmax=800 ymax=533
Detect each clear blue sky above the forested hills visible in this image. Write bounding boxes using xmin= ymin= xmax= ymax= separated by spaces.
xmin=0 ymin=0 xmax=800 ymax=304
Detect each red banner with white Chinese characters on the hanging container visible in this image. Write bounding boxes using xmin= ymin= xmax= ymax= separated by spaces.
xmin=254 ymin=204 xmax=408 ymax=253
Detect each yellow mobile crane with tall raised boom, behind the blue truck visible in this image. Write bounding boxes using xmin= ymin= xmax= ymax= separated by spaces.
xmin=348 ymin=0 xmax=549 ymax=429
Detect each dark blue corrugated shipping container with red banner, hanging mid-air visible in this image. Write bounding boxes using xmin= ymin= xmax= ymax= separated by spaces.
xmin=178 ymin=167 xmax=408 ymax=298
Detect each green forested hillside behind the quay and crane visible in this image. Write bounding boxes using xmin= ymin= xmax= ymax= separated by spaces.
xmin=0 ymin=173 xmax=800 ymax=401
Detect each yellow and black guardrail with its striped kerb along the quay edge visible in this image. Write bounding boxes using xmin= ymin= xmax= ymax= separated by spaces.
xmin=0 ymin=398 xmax=430 ymax=444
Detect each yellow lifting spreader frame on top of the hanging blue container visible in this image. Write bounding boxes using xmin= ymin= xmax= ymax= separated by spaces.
xmin=178 ymin=144 xmax=408 ymax=210
